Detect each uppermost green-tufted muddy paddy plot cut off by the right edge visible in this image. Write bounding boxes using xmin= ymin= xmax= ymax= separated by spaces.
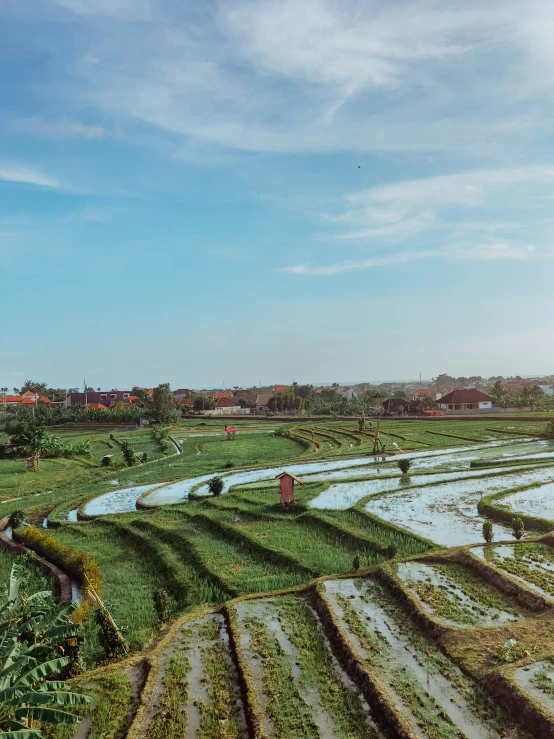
xmin=471 ymin=542 xmax=554 ymax=598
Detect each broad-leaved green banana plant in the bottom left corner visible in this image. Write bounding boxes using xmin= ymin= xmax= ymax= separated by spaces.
xmin=0 ymin=558 xmax=90 ymax=739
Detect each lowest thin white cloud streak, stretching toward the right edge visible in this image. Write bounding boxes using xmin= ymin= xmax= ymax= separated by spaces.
xmin=283 ymin=242 xmax=535 ymax=275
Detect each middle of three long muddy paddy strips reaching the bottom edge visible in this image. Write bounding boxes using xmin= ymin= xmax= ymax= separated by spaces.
xmin=236 ymin=596 xmax=383 ymax=739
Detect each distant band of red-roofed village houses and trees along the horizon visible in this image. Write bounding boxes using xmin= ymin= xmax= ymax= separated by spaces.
xmin=0 ymin=374 xmax=554 ymax=417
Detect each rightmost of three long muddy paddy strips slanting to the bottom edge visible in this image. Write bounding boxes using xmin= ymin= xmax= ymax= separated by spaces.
xmin=325 ymin=580 xmax=522 ymax=739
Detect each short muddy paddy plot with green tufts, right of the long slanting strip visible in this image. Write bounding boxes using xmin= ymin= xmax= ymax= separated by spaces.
xmin=396 ymin=561 xmax=529 ymax=627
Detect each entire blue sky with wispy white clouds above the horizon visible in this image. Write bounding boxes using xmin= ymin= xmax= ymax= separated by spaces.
xmin=0 ymin=0 xmax=554 ymax=388
